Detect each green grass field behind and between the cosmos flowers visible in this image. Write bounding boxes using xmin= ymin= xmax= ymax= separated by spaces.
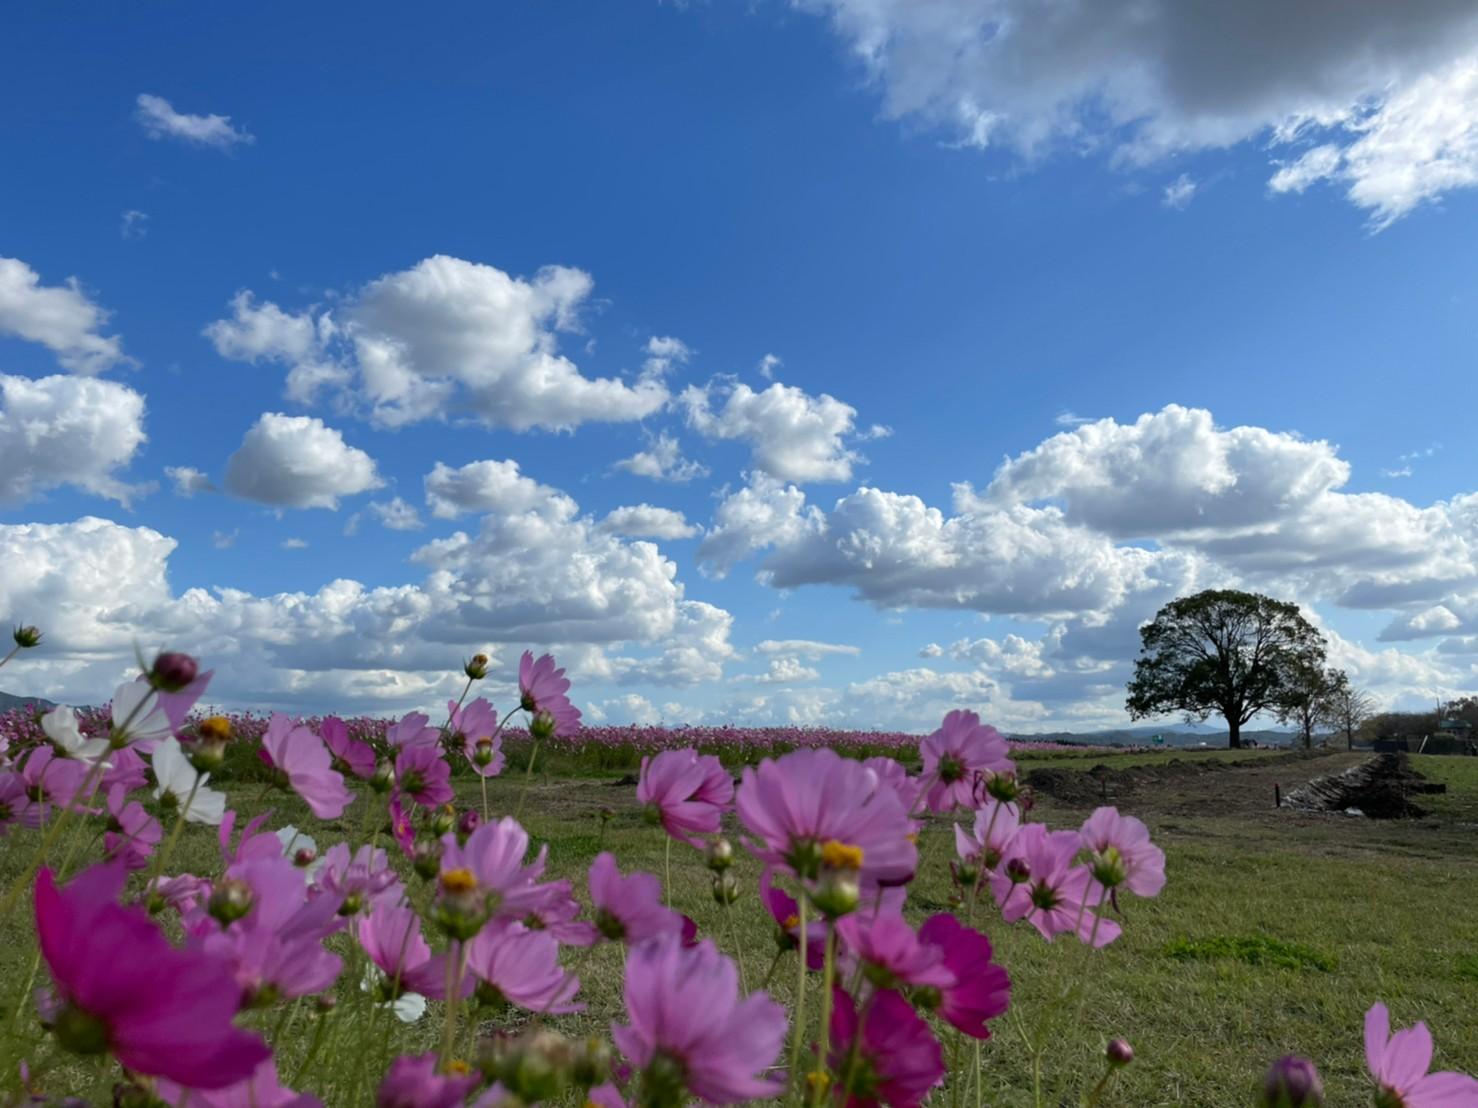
xmin=0 ymin=752 xmax=1478 ymax=1108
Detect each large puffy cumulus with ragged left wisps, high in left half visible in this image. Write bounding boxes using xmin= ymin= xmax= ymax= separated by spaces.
xmin=205 ymin=256 xmax=675 ymax=431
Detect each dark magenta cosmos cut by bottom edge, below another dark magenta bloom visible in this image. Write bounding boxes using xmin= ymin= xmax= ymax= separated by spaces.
xmin=831 ymin=988 xmax=944 ymax=1108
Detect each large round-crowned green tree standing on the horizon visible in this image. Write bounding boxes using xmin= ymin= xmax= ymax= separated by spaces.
xmin=1125 ymin=589 xmax=1324 ymax=748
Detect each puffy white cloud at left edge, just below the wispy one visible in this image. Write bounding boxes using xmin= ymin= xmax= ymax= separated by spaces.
xmin=0 ymin=374 xmax=146 ymax=504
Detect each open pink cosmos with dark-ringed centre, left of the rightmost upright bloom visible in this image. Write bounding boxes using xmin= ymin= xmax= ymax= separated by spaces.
xmin=990 ymin=823 xmax=1120 ymax=947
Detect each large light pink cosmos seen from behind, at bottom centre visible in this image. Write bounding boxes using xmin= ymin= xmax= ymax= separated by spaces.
xmin=610 ymin=935 xmax=786 ymax=1104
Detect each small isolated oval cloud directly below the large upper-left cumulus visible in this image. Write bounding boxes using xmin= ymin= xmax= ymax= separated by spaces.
xmin=225 ymin=412 xmax=384 ymax=510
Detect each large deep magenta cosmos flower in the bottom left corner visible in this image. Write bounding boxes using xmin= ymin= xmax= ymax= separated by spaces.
xmin=35 ymin=864 xmax=270 ymax=1089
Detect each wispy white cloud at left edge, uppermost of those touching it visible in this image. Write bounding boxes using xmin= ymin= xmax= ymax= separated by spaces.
xmin=0 ymin=257 xmax=133 ymax=375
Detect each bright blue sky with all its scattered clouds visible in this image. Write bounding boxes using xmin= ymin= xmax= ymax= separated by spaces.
xmin=0 ymin=0 xmax=1478 ymax=730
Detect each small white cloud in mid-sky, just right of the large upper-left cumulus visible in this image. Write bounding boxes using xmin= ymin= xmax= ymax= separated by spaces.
xmin=680 ymin=383 xmax=862 ymax=482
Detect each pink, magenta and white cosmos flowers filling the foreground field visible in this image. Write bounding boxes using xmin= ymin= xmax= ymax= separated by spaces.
xmin=0 ymin=628 xmax=1478 ymax=1108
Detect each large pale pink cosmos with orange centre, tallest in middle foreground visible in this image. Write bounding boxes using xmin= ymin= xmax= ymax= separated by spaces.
xmin=738 ymin=748 xmax=918 ymax=885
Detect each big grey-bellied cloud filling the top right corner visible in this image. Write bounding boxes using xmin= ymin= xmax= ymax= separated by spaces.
xmin=794 ymin=0 xmax=1478 ymax=226
